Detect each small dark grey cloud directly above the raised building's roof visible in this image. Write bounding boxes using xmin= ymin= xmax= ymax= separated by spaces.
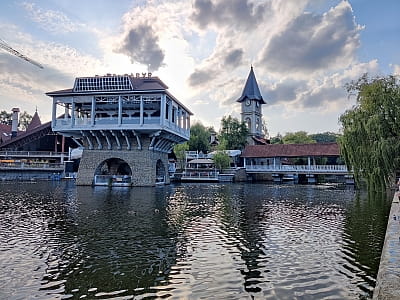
xmin=115 ymin=23 xmax=165 ymax=71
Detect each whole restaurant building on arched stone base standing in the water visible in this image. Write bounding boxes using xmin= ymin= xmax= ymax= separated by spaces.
xmin=46 ymin=73 xmax=192 ymax=186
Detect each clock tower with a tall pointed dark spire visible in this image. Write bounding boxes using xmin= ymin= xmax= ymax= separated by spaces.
xmin=237 ymin=66 xmax=266 ymax=145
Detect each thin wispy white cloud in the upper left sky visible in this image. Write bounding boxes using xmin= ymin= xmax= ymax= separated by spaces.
xmin=21 ymin=2 xmax=86 ymax=34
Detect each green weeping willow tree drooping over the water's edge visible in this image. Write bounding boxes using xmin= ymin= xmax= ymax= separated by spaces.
xmin=339 ymin=74 xmax=400 ymax=190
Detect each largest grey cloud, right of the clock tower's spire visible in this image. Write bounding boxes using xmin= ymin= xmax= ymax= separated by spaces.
xmin=260 ymin=1 xmax=362 ymax=74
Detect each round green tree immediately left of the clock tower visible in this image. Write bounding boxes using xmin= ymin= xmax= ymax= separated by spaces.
xmin=219 ymin=116 xmax=249 ymax=150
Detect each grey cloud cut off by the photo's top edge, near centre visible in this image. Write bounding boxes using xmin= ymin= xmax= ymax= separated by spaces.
xmin=191 ymin=0 xmax=270 ymax=29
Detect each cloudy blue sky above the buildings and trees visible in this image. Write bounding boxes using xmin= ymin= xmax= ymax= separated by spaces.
xmin=0 ymin=0 xmax=400 ymax=137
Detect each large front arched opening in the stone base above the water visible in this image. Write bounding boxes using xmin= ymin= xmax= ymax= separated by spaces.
xmin=94 ymin=158 xmax=132 ymax=186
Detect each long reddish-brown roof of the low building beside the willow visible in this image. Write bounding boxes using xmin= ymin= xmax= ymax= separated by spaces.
xmin=242 ymin=143 xmax=340 ymax=158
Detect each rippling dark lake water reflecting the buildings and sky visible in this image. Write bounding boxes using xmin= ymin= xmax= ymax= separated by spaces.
xmin=0 ymin=182 xmax=390 ymax=299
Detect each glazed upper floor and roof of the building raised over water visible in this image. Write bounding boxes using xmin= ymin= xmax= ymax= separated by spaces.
xmin=47 ymin=73 xmax=192 ymax=142
